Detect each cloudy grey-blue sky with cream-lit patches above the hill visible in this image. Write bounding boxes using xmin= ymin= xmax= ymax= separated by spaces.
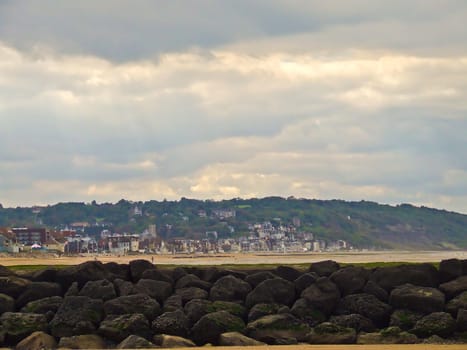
xmin=0 ymin=0 xmax=467 ymax=213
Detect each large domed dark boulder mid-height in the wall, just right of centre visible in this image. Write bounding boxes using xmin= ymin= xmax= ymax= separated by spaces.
xmin=245 ymin=277 xmax=295 ymax=308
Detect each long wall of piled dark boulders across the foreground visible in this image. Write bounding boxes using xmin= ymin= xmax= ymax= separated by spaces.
xmin=0 ymin=259 xmax=467 ymax=350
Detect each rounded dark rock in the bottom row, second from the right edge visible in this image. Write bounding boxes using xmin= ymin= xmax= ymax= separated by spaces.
xmin=410 ymin=312 xmax=457 ymax=338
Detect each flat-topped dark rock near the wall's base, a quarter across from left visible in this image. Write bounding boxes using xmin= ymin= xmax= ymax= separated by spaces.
xmin=98 ymin=314 xmax=152 ymax=342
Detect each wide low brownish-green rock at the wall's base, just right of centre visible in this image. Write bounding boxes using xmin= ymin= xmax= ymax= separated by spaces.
xmin=247 ymin=314 xmax=311 ymax=345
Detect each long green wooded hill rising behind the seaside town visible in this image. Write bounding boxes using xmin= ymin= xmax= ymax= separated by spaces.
xmin=0 ymin=197 xmax=467 ymax=249
